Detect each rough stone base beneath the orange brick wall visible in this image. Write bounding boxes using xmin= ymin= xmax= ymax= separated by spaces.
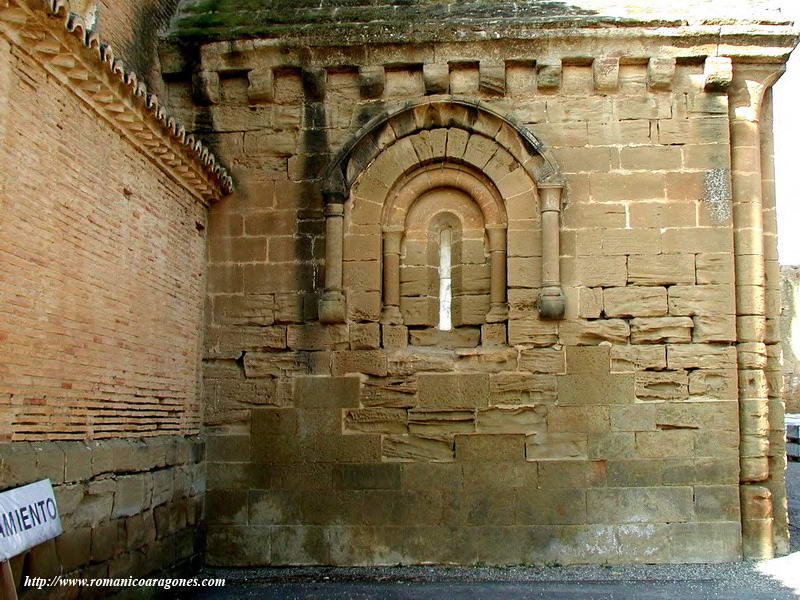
xmin=0 ymin=436 xmax=205 ymax=598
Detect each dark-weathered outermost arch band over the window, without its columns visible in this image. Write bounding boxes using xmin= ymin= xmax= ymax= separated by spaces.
xmin=322 ymin=96 xmax=562 ymax=202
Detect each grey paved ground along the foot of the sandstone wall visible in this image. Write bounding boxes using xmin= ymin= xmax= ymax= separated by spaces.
xmin=181 ymin=463 xmax=800 ymax=600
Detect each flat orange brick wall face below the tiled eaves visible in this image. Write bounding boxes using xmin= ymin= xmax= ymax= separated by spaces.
xmin=0 ymin=41 xmax=206 ymax=441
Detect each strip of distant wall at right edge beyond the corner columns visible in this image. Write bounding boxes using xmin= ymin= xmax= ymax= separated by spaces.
xmin=781 ymin=265 xmax=800 ymax=413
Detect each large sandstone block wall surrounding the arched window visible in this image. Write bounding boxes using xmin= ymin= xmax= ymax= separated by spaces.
xmin=170 ymin=29 xmax=783 ymax=565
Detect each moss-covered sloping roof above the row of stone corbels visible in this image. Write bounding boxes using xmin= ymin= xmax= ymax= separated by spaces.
xmin=169 ymin=0 xmax=781 ymax=46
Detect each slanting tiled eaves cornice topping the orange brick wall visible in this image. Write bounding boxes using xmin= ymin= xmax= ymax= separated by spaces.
xmin=0 ymin=0 xmax=233 ymax=202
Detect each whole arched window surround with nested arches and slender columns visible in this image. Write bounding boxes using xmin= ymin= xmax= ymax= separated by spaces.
xmin=320 ymin=97 xmax=564 ymax=326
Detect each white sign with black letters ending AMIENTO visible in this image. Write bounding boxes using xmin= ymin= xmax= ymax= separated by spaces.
xmin=0 ymin=479 xmax=64 ymax=561
